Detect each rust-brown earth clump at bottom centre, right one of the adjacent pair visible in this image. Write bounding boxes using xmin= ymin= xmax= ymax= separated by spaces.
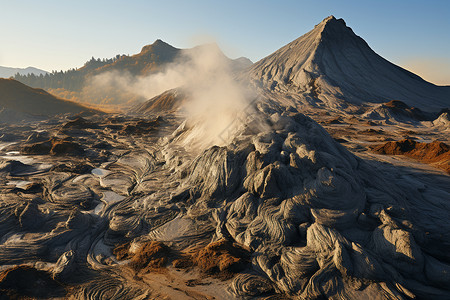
xmin=193 ymin=240 xmax=250 ymax=279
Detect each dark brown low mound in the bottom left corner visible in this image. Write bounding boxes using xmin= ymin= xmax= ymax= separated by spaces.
xmin=0 ymin=266 xmax=66 ymax=299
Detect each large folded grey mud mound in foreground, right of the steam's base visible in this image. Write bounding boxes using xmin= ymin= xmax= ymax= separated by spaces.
xmin=168 ymin=107 xmax=449 ymax=298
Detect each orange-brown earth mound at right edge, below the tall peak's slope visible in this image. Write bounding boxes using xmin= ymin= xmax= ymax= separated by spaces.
xmin=372 ymin=139 xmax=450 ymax=174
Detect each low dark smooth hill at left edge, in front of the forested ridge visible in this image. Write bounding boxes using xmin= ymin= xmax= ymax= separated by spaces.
xmin=0 ymin=78 xmax=96 ymax=123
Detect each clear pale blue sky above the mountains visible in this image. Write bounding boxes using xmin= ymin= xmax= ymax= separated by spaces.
xmin=0 ymin=0 xmax=450 ymax=84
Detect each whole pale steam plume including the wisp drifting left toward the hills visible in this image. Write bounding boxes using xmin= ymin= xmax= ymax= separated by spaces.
xmin=84 ymin=44 xmax=255 ymax=149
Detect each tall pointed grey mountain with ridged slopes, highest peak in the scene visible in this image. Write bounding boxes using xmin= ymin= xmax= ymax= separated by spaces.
xmin=247 ymin=16 xmax=450 ymax=110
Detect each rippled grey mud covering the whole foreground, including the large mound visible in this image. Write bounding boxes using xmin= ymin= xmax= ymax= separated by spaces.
xmin=0 ymin=105 xmax=450 ymax=299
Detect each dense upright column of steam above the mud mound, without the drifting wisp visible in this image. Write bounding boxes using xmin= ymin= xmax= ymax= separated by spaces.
xmin=171 ymin=45 xmax=255 ymax=150
